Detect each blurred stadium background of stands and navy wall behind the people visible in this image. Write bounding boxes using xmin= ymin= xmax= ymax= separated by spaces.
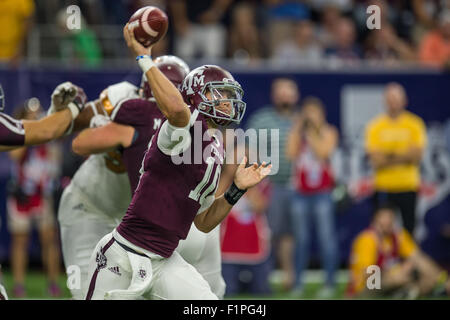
xmin=0 ymin=0 xmax=450 ymax=298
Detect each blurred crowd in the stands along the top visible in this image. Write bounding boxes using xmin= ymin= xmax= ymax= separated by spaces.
xmin=0 ymin=0 xmax=450 ymax=68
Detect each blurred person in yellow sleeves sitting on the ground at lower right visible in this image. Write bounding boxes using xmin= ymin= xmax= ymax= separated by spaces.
xmin=347 ymin=205 xmax=448 ymax=298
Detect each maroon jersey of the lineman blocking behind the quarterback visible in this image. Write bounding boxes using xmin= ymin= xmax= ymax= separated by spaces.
xmin=112 ymin=99 xmax=165 ymax=193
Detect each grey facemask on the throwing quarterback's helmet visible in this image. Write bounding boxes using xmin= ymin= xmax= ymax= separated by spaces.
xmin=198 ymin=80 xmax=246 ymax=126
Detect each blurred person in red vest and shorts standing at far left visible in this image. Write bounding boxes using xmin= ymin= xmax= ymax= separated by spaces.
xmin=7 ymin=98 xmax=61 ymax=297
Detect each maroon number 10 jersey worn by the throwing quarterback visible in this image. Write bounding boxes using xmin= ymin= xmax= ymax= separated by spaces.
xmin=117 ymin=111 xmax=223 ymax=258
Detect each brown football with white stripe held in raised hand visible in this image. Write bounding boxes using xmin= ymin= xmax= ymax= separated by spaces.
xmin=128 ymin=6 xmax=169 ymax=47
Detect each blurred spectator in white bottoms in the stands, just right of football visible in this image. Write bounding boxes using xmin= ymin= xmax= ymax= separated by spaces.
xmin=170 ymin=0 xmax=232 ymax=59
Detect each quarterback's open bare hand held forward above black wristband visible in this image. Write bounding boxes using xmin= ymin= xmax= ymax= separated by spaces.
xmin=234 ymin=157 xmax=272 ymax=190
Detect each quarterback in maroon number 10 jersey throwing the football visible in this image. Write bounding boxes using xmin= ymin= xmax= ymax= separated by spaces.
xmin=81 ymin=25 xmax=271 ymax=300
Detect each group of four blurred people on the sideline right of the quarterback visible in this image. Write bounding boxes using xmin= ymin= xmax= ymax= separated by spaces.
xmin=237 ymin=78 xmax=450 ymax=298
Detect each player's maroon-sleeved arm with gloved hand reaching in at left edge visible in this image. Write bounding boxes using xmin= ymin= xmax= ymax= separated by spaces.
xmin=0 ymin=82 xmax=86 ymax=300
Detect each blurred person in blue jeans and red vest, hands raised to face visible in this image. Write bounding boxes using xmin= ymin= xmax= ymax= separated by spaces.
xmin=286 ymin=97 xmax=339 ymax=298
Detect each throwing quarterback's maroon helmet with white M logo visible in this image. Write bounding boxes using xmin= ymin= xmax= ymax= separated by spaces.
xmin=181 ymin=65 xmax=246 ymax=126
